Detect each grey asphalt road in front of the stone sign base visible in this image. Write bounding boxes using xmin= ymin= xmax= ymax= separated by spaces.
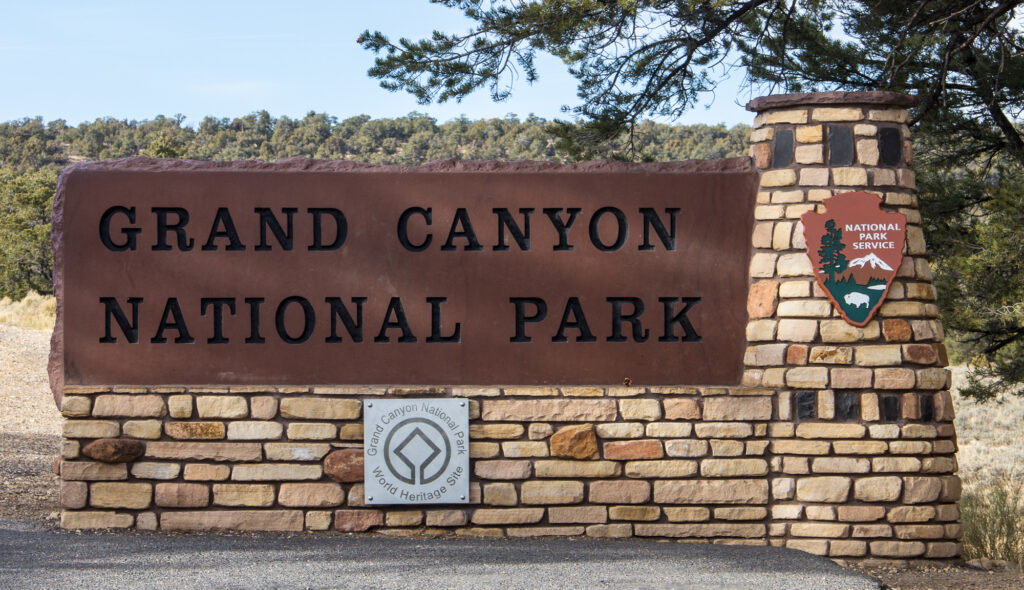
xmin=0 ymin=519 xmax=880 ymax=590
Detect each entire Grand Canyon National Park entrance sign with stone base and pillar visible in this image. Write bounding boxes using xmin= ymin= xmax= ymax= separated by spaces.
xmin=56 ymin=92 xmax=961 ymax=560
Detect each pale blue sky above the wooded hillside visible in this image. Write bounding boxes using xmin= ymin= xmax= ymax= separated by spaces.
xmin=0 ymin=0 xmax=753 ymax=125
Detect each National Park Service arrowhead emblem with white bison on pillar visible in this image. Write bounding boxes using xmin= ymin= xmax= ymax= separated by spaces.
xmin=800 ymin=191 xmax=906 ymax=326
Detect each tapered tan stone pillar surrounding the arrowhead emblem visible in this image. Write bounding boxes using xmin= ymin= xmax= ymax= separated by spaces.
xmin=743 ymin=92 xmax=961 ymax=560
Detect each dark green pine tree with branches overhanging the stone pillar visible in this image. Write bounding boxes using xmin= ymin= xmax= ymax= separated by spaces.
xmin=357 ymin=0 xmax=1024 ymax=397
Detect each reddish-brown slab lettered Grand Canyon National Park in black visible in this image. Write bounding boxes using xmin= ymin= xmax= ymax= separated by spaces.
xmin=51 ymin=159 xmax=757 ymax=389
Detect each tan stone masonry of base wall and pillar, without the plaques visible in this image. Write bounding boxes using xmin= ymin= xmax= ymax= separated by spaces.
xmin=60 ymin=93 xmax=959 ymax=560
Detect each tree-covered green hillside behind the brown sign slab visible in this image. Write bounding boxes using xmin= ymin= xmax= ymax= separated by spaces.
xmin=0 ymin=111 xmax=751 ymax=299
